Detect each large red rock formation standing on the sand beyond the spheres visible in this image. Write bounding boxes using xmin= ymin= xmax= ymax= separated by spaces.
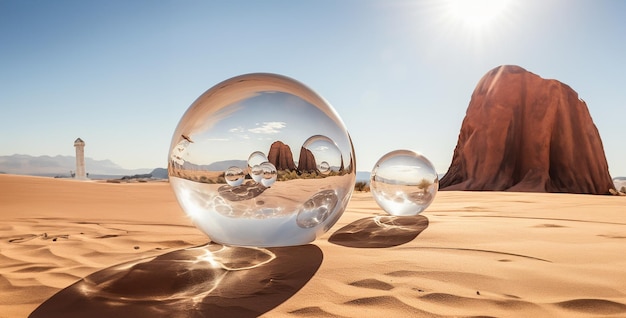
xmin=439 ymin=65 xmax=614 ymax=194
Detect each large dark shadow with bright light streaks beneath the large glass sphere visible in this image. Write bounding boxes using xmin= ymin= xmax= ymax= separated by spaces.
xmin=29 ymin=244 xmax=323 ymax=318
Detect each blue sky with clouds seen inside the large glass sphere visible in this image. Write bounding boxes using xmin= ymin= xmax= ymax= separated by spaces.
xmin=188 ymin=92 xmax=347 ymax=166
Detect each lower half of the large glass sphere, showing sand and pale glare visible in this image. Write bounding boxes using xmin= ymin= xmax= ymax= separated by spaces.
xmin=170 ymin=176 xmax=352 ymax=246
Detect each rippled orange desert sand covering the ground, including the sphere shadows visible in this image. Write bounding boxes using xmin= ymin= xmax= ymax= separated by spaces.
xmin=0 ymin=175 xmax=626 ymax=317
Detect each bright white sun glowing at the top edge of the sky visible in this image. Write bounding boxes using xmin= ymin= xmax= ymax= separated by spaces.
xmin=445 ymin=0 xmax=510 ymax=29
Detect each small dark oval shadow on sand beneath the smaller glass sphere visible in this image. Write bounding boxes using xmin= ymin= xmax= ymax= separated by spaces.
xmin=328 ymin=215 xmax=428 ymax=248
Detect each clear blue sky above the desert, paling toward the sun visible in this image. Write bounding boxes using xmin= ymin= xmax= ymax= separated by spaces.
xmin=0 ymin=0 xmax=626 ymax=177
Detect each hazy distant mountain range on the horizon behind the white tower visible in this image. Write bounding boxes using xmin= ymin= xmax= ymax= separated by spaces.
xmin=0 ymin=155 xmax=153 ymax=179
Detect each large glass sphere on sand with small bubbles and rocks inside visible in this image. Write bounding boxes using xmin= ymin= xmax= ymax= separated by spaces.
xmin=168 ymin=74 xmax=356 ymax=247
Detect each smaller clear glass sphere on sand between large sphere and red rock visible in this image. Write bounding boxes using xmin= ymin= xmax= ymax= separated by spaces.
xmin=370 ymin=150 xmax=439 ymax=216
